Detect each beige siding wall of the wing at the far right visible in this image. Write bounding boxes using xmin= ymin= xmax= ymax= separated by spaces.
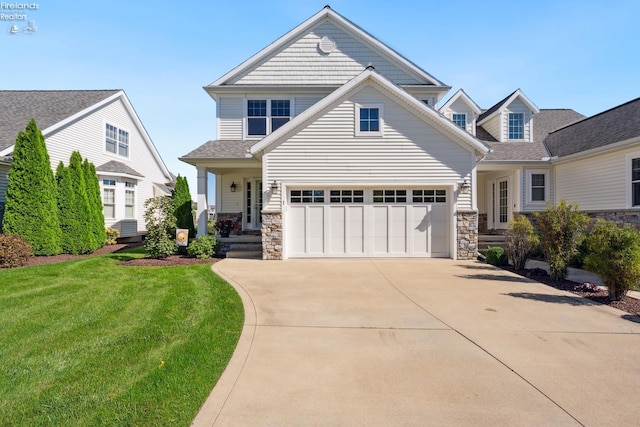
xmin=555 ymin=148 xmax=640 ymax=211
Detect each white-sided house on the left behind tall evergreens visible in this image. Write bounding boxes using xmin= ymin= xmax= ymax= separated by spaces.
xmin=0 ymin=90 xmax=174 ymax=238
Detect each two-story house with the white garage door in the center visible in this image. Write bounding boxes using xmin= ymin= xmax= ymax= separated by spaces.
xmin=181 ymin=6 xmax=640 ymax=259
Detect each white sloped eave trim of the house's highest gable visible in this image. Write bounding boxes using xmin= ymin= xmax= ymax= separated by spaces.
xmin=207 ymin=5 xmax=446 ymax=87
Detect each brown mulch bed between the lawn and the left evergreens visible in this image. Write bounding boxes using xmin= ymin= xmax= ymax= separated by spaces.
xmin=27 ymin=243 xmax=219 ymax=267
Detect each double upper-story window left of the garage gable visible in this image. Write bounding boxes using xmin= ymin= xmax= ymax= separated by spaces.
xmin=247 ymin=99 xmax=291 ymax=137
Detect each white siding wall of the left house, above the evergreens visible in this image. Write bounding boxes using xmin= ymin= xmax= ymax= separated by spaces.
xmin=46 ymin=98 xmax=171 ymax=237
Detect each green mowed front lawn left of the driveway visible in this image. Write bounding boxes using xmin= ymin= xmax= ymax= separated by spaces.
xmin=0 ymin=254 xmax=244 ymax=426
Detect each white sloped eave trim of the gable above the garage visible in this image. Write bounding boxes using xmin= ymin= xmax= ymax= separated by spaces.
xmin=251 ymin=67 xmax=489 ymax=155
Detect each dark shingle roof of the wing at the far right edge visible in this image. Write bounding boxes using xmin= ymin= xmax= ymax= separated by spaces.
xmin=544 ymin=98 xmax=640 ymax=157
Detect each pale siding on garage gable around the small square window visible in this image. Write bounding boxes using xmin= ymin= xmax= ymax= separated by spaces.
xmin=264 ymin=87 xmax=475 ymax=209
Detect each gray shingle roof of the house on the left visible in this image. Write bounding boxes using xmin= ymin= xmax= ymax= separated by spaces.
xmin=0 ymin=90 xmax=120 ymax=150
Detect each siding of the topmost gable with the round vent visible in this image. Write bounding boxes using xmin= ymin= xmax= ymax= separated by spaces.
xmin=229 ymin=20 xmax=425 ymax=85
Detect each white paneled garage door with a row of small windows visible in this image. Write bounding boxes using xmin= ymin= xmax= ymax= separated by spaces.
xmin=285 ymin=188 xmax=450 ymax=258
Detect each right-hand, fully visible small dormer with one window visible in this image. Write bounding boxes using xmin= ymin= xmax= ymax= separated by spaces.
xmin=477 ymin=89 xmax=540 ymax=142
